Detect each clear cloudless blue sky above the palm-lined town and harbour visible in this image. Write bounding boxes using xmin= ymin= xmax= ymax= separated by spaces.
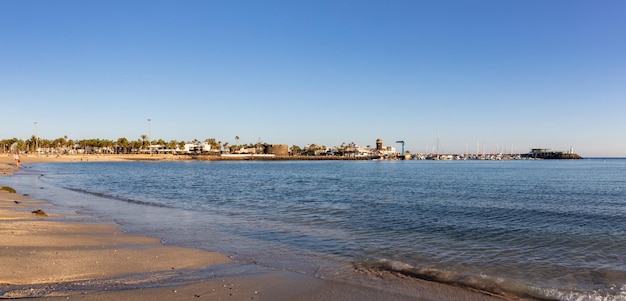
xmin=0 ymin=0 xmax=626 ymax=157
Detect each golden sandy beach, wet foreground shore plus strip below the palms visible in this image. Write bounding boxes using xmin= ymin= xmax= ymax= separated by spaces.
xmin=0 ymin=155 xmax=503 ymax=300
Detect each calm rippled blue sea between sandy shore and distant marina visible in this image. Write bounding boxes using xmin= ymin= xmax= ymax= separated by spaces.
xmin=8 ymin=159 xmax=626 ymax=300
